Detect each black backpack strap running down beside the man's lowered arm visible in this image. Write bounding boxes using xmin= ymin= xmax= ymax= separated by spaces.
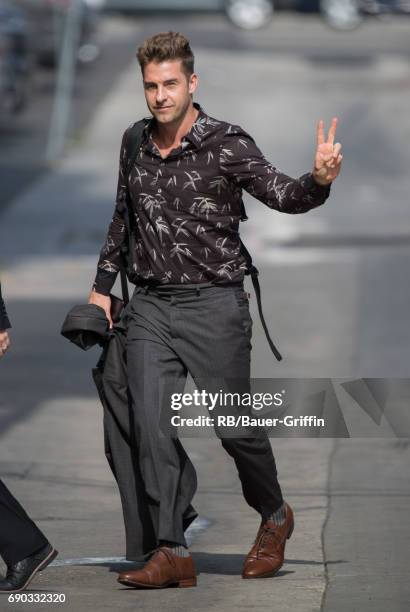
xmin=120 ymin=119 xmax=146 ymax=304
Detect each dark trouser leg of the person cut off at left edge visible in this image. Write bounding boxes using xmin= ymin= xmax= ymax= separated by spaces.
xmin=0 ymin=480 xmax=48 ymax=566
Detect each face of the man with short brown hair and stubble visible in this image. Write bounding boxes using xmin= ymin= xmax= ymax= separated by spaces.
xmin=143 ymin=60 xmax=197 ymax=124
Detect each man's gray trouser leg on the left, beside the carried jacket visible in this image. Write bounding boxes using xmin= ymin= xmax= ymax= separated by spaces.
xmin=127 ymin=293 xmax=196 ymax=546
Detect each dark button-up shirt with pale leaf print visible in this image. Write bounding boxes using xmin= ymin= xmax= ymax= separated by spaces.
xmin=94 ymin=105 xmax=330 ymax=295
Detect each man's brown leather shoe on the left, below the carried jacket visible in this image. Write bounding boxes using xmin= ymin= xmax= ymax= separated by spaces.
xmin=118 ymin=546 xmax=196 ymax=589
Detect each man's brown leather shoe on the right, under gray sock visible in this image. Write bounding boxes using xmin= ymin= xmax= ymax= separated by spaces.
xmin=242 ymin=502 xmax=294 ymax=578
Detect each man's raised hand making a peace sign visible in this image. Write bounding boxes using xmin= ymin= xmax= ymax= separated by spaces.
xmin=313 ymin=117 xmax=343 ymax=185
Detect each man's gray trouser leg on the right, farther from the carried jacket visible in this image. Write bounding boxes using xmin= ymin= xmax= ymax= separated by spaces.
xmin=173 ymin=287 xmax=283 ymax=518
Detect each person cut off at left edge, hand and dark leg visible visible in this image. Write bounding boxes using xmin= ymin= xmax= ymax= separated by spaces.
xmin=0 ymin=284 xmax=58 ymax=593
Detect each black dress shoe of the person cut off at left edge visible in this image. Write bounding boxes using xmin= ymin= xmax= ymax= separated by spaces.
xmin=0 ymin=544 xmax=58 ymax=593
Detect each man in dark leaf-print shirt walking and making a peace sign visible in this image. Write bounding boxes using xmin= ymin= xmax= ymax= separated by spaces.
xmin=89 ymin=32 xmax=342 ymax=588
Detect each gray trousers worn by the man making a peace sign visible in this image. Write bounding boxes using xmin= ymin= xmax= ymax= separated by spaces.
xmin=124 ymin=283 xmax=283 ymax=545
